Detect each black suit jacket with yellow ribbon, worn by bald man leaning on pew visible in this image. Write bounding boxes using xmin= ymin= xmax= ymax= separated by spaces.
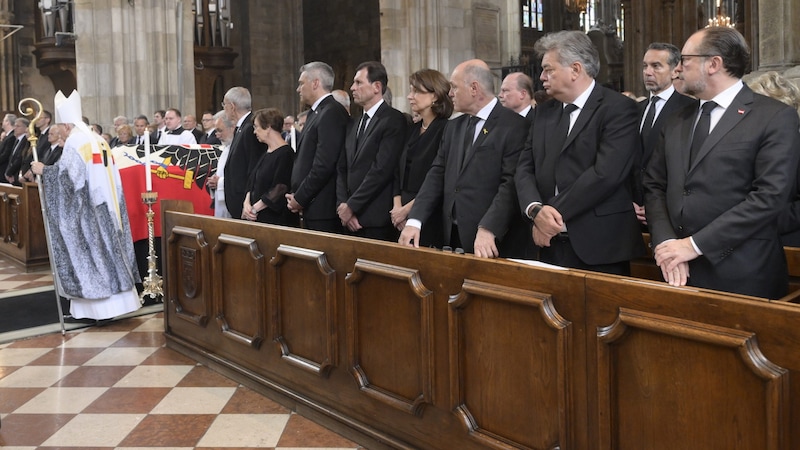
xmin=409 ymin=102 xmax=527 ymax=257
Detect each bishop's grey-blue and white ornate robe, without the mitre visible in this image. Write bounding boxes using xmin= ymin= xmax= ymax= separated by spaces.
xmin=42 ymin=127 xmax=141 ymax=320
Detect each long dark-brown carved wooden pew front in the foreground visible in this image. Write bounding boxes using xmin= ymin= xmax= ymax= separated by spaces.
xmin=162 ymin=202 xmax=800 ymax=450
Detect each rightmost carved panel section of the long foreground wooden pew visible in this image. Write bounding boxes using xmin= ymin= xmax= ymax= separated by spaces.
xmin=586 ymin=275 xmax=800 ymax=450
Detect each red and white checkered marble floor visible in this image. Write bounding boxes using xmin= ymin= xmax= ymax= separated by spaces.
xmin=0 ymin=255 xmax=363 ymax=450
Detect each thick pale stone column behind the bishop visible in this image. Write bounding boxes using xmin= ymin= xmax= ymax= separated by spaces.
xmin=75 ymin=0 xmax=195 ymax=128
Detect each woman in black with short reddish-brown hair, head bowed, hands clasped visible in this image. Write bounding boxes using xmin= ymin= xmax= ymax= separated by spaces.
xmin=242 ymin=108 xmax=294 ymax=226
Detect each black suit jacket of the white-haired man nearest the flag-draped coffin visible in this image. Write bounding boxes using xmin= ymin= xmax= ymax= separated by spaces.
xmin=224 ymin=112 xmax=267 ymax=219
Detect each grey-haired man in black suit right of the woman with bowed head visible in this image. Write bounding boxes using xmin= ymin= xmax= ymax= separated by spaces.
xmin=286 ymin=61 xmax=350 ymax=233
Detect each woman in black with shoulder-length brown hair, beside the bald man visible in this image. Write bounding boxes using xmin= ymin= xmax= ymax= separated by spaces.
xmin=390 ymin=69 xmax=453 ymax=247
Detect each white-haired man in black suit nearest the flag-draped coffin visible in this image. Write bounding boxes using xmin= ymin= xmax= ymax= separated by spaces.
xmin=222 ymin=86 xmax=267 ymax=219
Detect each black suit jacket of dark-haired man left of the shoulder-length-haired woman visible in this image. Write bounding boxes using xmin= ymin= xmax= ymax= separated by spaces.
xmin=336 ymin=102 xmax=407 ymax=227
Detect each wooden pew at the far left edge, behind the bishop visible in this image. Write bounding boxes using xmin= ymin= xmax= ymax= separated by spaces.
xmin=0 ymin=183 xmax=49 ymax=270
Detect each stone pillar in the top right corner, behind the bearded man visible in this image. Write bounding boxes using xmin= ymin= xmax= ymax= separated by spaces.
xmin=758 ymin=0 xmax=800 ymax=82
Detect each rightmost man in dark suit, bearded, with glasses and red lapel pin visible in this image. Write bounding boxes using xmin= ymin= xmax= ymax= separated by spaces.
xmin=644 ymin=27 xmax=800 ymax=298
